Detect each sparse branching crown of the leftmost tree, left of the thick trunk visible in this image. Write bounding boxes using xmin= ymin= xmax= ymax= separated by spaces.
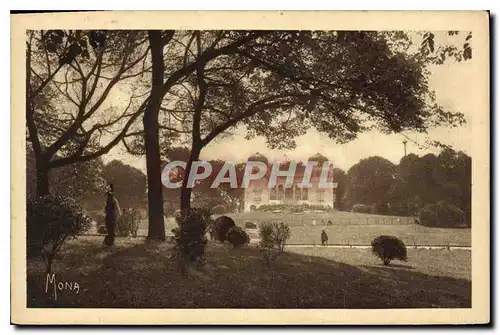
xmin=26 ymin=30 xmax=148 ymax=195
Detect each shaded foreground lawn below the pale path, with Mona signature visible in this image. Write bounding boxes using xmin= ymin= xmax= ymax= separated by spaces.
xmin=27 ymin=237 xmax=471 ymax=308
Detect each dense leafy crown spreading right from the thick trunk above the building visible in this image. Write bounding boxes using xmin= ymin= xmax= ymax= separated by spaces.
xmin=137 ymin=31 xmax=472 ymax=215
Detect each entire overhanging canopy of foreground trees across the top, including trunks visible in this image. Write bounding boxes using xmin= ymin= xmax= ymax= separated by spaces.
xmin=26 ymin=30 xmax=472 ymax=239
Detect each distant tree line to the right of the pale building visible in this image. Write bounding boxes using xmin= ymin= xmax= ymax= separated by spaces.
xmin=337 ymin=149 xmax=471 ymax=224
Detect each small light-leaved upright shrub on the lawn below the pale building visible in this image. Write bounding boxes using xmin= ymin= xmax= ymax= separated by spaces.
xmin=259 ymin=221 xmax=292 ymax=266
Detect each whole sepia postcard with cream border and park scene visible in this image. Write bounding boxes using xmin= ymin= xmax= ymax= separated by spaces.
xmin=11 ymin=11 xmax=490 ymax=325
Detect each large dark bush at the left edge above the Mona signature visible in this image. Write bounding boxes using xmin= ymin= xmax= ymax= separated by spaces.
xmin=27 ymin=195 xmax=92 ymax=273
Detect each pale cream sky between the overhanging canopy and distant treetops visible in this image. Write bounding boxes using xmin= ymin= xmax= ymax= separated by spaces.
xmin=103 ymin=38 xmax=479 ymax=171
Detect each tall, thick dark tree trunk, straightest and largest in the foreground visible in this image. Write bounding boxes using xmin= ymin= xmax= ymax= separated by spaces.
xmin=143 ymin=30 xmax=165 ymax=241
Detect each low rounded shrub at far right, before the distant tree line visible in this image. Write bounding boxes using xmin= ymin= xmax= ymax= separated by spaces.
xmin=419 ymin=202 xmax=465 ymax=228
